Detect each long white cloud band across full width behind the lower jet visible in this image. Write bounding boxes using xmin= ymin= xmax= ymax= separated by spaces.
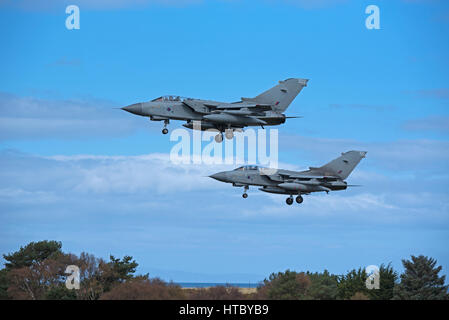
xmin=0 ymin=152 xmax=449 ymax=226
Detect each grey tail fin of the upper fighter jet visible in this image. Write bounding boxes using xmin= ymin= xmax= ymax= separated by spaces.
xmin=242 ymin=78 xmax=309 ymax=112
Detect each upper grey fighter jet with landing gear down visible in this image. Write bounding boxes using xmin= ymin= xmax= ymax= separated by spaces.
xmin=122 ymin=78 xmax=308 ymax=142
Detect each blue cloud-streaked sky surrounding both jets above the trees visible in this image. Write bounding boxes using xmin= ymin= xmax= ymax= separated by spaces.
xmin=0 ymin=0 xmax=449 ymax=282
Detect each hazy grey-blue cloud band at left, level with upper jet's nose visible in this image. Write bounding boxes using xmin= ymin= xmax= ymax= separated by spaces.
xmin=0 ymin=93 xmax=143 ymax=140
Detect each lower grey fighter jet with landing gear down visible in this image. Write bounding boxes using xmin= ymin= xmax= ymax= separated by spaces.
xmin=210 ymin=151 xmax=366 ymax=205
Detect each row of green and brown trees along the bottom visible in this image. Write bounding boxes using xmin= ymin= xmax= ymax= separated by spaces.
xmin=0 ymin=240 xmax=449 ymax=300
